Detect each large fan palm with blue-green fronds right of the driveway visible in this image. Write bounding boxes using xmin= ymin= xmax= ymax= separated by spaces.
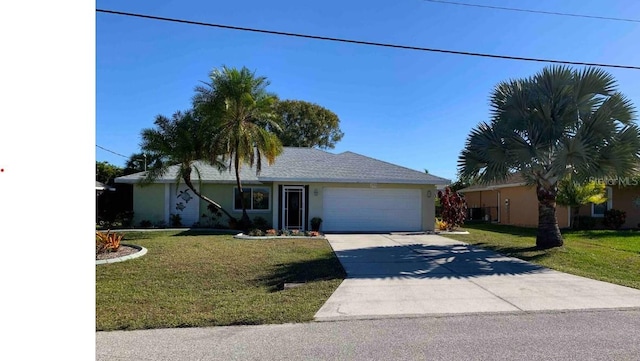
xmin=458 ymin=66 xmax=640 ymax=248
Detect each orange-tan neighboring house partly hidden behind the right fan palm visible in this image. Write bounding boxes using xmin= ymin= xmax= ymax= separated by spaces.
xmin=459 ymin=174 xmax=640 ymax=228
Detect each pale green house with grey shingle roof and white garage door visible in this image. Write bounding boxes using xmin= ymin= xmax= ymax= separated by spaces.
xmin=116 ymin=147 xmax=450 ymax=232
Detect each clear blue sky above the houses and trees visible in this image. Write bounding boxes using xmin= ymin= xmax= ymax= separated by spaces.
xmin=95 ymin=0 xmax=640 ymax=179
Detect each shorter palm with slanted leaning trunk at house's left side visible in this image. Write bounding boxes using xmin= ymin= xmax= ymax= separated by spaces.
xmin=141 ymin=110 xmax=236 ymax=223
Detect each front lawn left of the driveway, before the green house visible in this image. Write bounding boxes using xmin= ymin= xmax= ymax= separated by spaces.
xmin=96 ymin=231 xmax=345 ymax=330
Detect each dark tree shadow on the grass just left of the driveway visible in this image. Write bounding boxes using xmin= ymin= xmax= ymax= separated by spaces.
xmin=253 ymin=255 xmax=347 ymax=292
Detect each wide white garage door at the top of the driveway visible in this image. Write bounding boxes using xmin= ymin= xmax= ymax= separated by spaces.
xmin=322 ymin=188 xmax=422 ymax=232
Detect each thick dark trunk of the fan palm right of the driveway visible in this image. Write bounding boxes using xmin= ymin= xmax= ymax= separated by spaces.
xmin=536 ymin=185 xmax=563 ymax=248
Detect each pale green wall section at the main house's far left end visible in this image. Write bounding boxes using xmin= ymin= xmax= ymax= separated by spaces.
xmin=133 ymin=184 xmax=165 ymax=226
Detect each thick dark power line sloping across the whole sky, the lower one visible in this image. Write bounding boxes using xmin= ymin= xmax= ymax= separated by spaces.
xmin=96 ymin=9 xmax=640 ymax=70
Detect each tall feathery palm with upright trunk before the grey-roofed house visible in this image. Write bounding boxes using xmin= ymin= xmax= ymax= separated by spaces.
xmin=194 ymin=66 xmax=282 ymax=228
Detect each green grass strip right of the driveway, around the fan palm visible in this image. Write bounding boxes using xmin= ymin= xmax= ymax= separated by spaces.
xmin=447 ymin=223 xmax=640 ymax=289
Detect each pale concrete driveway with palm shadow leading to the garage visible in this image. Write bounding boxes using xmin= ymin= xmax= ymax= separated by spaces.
xmin=315 ymin=234 xmax=640 ymax=321
